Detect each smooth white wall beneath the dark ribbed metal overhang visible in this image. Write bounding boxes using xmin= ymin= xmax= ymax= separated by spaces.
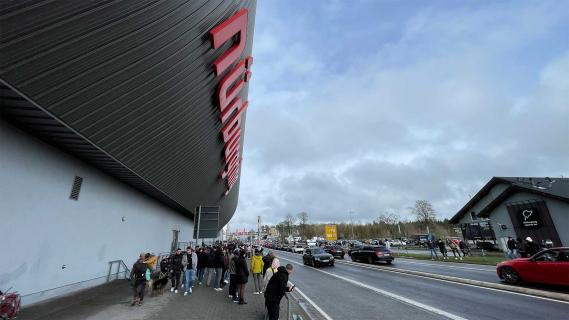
xmin=0 ymin=120 xmax=193 ymax=304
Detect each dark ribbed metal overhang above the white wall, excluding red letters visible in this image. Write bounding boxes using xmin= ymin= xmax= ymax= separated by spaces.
xmin=0 ymin=0 xmax=256 ymax=226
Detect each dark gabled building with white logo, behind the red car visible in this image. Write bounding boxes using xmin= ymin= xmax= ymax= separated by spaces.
xmin=450 ymin=177 xmax=569 ymax=249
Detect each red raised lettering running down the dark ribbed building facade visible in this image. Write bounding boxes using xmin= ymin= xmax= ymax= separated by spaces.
xmin=209 ymin=8 xmax=253 ymax=195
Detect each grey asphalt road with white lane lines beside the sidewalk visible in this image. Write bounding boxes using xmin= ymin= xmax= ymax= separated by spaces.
xmin=276 ymin=251 xmax=569 ymax=320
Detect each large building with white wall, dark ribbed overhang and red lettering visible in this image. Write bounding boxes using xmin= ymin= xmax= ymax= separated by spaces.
xmin=0 ymin=0 xmax=256 ymax=304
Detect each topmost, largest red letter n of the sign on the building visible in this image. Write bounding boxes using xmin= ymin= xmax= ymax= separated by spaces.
xmin=209 ymin=8 xmax=248 ymax=76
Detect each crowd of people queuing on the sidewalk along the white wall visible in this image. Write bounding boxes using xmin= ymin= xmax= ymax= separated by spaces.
xmin=131 ymin=243 xmax=294 ymax=320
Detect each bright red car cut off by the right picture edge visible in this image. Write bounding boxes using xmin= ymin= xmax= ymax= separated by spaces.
xmin=496 ymin=247 xmax=569 ymax=286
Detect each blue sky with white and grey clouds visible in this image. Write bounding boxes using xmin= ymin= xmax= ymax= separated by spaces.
xmin=230 ymin=0 xmax=569 ymax=231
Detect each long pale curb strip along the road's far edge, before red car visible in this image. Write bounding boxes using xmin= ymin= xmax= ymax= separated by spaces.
xmin=343 ymin=261 xmax=569 ymax=302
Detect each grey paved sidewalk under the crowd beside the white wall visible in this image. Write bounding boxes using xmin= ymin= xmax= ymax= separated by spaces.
xmin=18 ymin=278 xmax=308 ymax=320
